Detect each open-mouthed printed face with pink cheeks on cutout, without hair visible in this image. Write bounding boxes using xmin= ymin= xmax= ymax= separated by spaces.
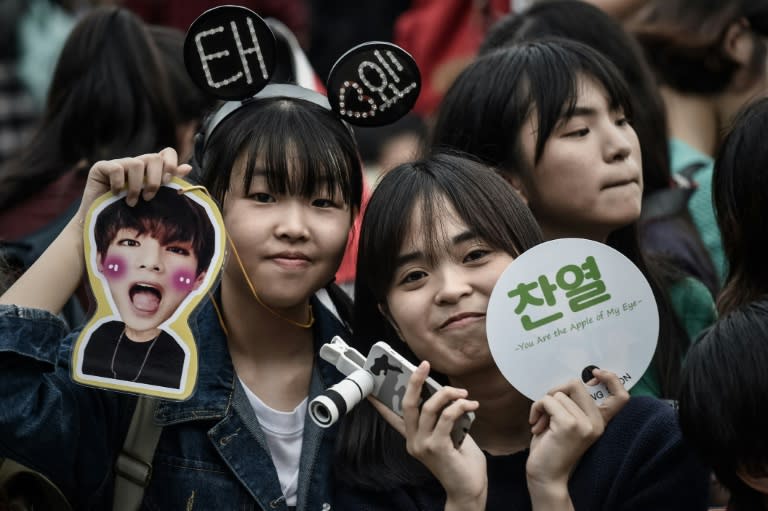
xmin=98 ymin=228 xmax=205 ymax=341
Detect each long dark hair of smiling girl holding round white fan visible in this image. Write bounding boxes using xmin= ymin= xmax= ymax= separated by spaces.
xmin=336 ymin=154 xmax=543 ymax=490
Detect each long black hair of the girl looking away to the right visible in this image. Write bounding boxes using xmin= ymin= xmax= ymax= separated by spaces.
xmin=432 ymin=39 xmax=690 ymax=397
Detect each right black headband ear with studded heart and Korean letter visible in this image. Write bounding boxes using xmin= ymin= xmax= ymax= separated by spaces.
xmin=327 ymin=42 xmax=421 ymax=126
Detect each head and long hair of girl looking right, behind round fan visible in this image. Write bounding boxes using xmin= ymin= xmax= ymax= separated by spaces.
xmin=431 ymin=40 xmax=714 ymax=399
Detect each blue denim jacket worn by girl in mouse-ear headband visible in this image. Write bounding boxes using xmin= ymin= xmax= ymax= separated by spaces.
xmin=0 ymin=301 xmax=347 ymax=511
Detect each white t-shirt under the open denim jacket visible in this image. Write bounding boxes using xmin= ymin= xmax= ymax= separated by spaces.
xmin=238 ymin=378 xmax=309 ymax=506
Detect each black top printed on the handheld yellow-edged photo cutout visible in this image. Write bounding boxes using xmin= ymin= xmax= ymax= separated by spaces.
xmin=83 ymin=321 xmax=184 ymax=389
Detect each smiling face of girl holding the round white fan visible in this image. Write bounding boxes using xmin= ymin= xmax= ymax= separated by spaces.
xmin=381 ymin=204 xmax=513 ymax=378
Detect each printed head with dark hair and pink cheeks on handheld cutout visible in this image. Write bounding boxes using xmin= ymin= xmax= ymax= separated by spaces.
xmin=94 ymin=187 xmax=218 ymax=341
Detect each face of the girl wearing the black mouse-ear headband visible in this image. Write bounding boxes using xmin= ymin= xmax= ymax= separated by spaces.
xmin=224 ymin=156 xmax=352 ymax=321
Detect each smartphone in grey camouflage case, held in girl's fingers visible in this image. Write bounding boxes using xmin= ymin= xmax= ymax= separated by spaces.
xmin=364 ymin=341 xmax=475 ymax=449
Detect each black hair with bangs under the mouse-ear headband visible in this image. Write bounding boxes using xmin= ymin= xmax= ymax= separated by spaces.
xmin=203 ymin=98 xmax=363 ymax=209
